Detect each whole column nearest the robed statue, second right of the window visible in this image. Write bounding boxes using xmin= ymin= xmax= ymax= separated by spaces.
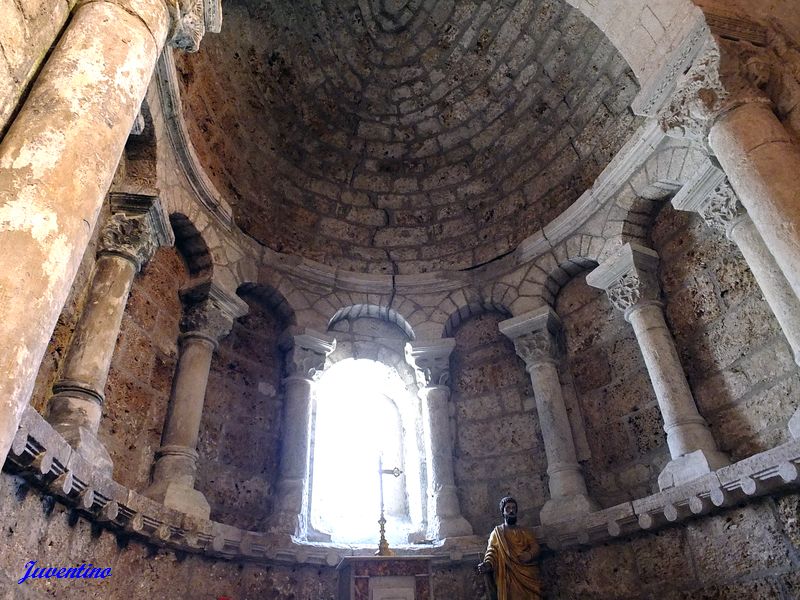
xmin=500 ymin=306 xmax=599 ymax=525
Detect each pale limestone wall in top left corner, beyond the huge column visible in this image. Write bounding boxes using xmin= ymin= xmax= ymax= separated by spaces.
xmin=0 ymin=0 xmax=75 ymax=133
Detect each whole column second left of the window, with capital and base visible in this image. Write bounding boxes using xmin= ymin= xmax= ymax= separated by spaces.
xmin=145 ymin=283 xmax=247 ymax=519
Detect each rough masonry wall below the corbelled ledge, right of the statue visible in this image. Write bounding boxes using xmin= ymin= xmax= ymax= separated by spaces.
xmin=542 ymin=494 xmax=800 ymax=600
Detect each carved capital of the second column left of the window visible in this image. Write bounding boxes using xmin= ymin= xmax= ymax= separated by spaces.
xmin=181 ymin=282 xmax=248 ymax=346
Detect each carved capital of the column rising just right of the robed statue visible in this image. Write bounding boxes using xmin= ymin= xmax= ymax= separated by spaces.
xmin=499 ymin=306 xmax=564 ymax=371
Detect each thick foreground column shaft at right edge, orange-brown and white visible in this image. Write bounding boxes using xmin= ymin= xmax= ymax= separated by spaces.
xmin=708 ymin=103 xmax=800 ymax=298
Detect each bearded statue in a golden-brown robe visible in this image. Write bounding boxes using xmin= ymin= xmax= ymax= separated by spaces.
xmin=478 ymin=496 xmax=542 ymax=600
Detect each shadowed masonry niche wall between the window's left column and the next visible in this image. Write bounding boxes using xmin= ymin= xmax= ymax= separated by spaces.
xmin=196 ymin=295 xmax=283 ymax=530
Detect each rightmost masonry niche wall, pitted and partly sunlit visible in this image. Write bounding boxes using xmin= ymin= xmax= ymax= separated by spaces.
xmin=651 ymin=206 xmax=800 ymax=460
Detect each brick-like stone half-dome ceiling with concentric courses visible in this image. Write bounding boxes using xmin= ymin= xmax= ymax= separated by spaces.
xmin=177 ymin=0 xmax=637 ymax=274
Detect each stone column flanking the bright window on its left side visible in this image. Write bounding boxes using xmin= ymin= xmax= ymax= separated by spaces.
xmin=270 ymin=330 xmax=336 ymax=539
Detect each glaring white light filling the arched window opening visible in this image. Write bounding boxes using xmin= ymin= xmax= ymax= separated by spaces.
xmin=311 ymin=359 xmax=418 ymax=545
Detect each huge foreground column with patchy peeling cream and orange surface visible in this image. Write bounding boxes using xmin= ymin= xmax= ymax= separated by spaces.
xmin=0 ymin=0 xmax=218 ymax=459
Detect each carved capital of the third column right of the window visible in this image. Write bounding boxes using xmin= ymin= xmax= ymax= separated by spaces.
xmin=586 ymin=243 xmax=661 ymax=319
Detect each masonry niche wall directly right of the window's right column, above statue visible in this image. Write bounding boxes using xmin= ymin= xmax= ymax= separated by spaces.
xmin=450 ymin=313 xmax=548 ymax=535
